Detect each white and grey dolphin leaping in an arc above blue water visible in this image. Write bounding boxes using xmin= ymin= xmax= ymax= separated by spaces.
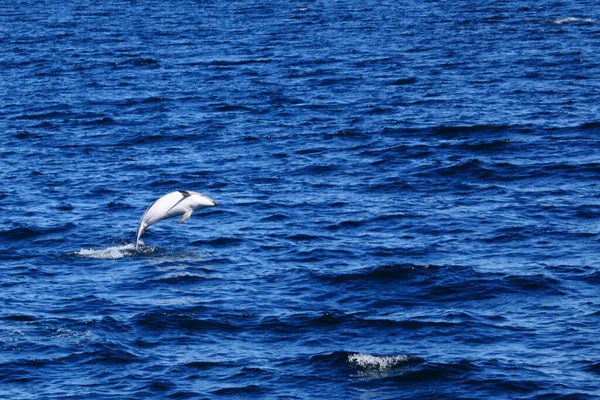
xmin=135 ymin=190 xmax=217 ymax=249
